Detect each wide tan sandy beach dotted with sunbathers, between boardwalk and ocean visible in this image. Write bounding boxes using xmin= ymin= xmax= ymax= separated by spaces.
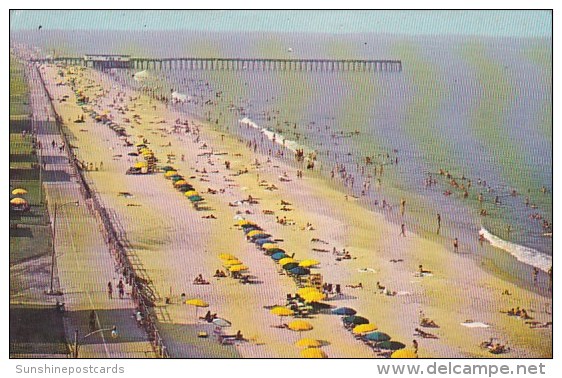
xmin=41 ymin=62 xmax=552 ymax=358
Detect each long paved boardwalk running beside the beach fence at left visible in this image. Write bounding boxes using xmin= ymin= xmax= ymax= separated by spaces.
xmin=28 ymin=64 xmax=155 ymax=358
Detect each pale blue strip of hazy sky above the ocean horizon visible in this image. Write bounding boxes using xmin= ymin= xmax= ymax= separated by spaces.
xmin=10 ymin=10 xmax=552 ymax=37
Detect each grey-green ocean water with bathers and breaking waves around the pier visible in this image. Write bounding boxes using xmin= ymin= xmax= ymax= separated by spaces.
xmin=12 ymin=31 xmax=553 ymax=271
